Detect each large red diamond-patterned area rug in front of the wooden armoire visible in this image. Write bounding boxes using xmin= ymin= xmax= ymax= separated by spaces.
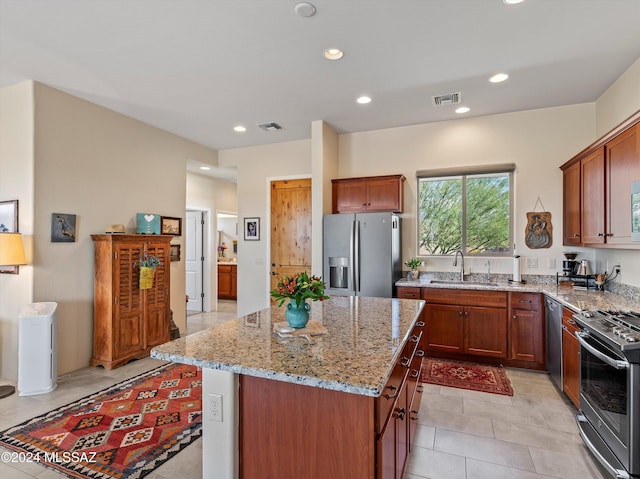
xmin=0 ymin=364 xmax=202 ymax=479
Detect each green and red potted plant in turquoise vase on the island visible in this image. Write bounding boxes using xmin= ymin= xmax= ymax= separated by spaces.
xmin=271 ymin=271 xmax=329 ymax=328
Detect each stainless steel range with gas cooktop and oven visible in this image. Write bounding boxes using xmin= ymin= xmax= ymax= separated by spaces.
xmin=573 ymin=309 xmax=640 ymax=479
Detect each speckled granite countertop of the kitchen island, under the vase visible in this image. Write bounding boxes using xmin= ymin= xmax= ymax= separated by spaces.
xmin=151 ymin=296 xmax=424 ymax=397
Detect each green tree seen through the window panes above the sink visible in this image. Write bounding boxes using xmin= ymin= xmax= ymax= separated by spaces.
xmin=418 ymin=172 xmax=512 ymax=256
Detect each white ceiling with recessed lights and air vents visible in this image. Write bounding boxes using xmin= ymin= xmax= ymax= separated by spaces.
xmin=0 ymin=0 xmax=640 ymax=169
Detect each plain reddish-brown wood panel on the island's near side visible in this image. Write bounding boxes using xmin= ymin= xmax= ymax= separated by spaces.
xmin=239 ymin=375 xmax=376 ymax=479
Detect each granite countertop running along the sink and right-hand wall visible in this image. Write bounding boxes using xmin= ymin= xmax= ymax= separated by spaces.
xmin=396 ymin=279 xmax=640 ymax=311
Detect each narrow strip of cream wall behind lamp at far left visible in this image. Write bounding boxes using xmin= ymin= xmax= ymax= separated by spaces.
xmin=0 ymin=82 xmax=34 ymax=379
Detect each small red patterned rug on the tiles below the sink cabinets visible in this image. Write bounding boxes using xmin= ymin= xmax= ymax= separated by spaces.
xmin=421 ymin=358 xmax=513 ymax=396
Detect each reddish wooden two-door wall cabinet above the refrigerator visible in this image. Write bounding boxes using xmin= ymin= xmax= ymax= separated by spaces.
xmin=331 ymin=175 xmax=405 ymax=213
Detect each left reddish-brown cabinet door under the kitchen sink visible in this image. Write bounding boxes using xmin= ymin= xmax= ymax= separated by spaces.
xmin=425 ymin=304 xmax=464 ymax=353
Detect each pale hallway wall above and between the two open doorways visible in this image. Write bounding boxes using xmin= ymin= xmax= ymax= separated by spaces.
xmin=187 ymin=172 xmax=238 ymax=310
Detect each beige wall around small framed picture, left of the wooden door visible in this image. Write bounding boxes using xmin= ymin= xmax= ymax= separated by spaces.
xmin=218 ymin=140 xmax=312 ymax=315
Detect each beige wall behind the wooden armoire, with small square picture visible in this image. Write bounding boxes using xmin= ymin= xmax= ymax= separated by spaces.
xmin=2 ymin=83 xmax=216 ymax=378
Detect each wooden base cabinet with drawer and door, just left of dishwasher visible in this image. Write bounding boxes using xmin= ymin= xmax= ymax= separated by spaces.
xmin=509 ymin=292 xmax=546 ymax=369
